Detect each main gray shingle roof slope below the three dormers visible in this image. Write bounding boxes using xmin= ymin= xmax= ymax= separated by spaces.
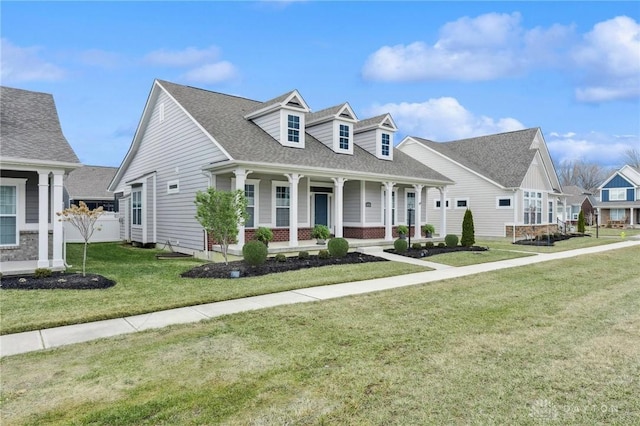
xmin=158 ymin=80 xmax=451 ymax=182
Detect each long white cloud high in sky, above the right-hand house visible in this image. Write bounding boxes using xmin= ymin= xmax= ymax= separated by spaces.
xmin=362 ymin=13 xmax=571 ymax=81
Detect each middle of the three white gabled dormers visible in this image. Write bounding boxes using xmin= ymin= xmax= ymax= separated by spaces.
xmin=306 ymin=103 xmax=358 ymax=155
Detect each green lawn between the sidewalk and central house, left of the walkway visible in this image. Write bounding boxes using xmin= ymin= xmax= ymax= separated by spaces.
xmin=0 ymin=243 xmax=429 ymax=334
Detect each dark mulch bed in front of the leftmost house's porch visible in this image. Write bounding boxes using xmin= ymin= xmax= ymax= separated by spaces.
xmin=0 ymin=272 xmax=116 ymax=290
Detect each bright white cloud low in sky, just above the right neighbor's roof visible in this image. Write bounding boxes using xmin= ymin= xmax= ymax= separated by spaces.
xmin=368 ymin=97 xmax=525 ymax=141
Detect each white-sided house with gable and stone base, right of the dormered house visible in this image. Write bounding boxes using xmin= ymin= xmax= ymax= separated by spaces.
xmin=398 ymin=128 xmax=561 ymax=238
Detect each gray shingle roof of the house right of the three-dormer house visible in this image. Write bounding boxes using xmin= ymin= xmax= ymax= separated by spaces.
xmin=412 ymin=128 xmax=539 ymax=188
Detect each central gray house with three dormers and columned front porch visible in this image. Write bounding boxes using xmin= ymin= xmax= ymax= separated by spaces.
xmin=109 ymin=80 xmax=453 ymax=255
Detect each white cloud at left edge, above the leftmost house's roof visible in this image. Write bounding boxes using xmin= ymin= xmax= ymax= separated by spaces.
xmin=0 ymin=38 xmax=66 ymax=84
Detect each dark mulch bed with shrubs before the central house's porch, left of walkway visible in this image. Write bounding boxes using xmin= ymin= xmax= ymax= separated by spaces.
xmin=181 ymin=252 xmax=386 ymax=278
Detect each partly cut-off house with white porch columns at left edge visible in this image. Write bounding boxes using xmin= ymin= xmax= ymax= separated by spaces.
xmin=0 ymin=87 xmax=81 ymax=273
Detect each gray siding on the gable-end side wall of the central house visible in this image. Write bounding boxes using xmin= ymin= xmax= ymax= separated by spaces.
xmin=116 ymin=91 xmax=226 ymax=250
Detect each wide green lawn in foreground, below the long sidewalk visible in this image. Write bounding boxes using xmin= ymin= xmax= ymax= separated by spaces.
xmin=0 ymin=246 xmax=640 ymax=425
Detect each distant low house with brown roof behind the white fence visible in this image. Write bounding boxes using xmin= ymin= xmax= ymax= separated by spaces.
xmin=64 ymin=166 xmax=118 ymax=212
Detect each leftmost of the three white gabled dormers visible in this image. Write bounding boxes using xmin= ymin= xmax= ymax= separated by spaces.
xmin=244 ymin=90 xmax=309 ymax=148
